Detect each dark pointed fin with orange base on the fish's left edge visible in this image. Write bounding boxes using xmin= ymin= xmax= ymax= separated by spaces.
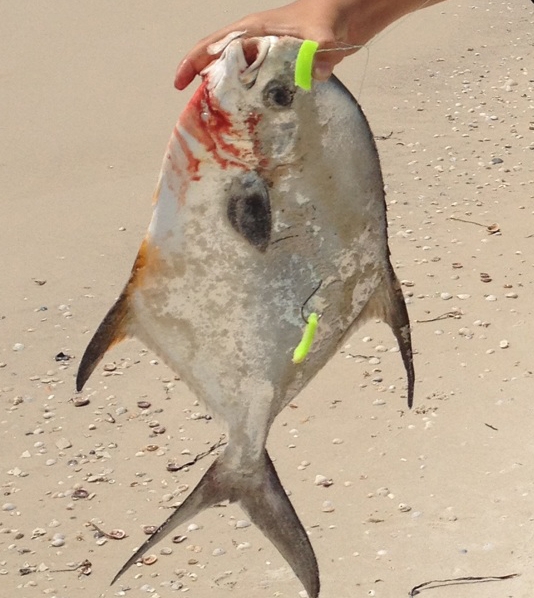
xmin=76 ymin=292 xmax=129 ymax=392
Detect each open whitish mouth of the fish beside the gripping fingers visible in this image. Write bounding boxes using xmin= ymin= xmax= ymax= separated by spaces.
xmin=201 ymin=31 xmax=277 ymax=89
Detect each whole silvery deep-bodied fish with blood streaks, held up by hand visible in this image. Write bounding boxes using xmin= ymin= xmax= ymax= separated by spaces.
xmin=76 ymin=32 xmax=415 ymax=598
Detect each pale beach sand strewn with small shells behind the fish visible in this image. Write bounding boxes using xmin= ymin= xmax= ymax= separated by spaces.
xmin=0 ymin=0 xmax=534 ymax=598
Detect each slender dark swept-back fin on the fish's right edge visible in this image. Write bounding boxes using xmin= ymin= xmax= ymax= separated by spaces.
xmin=361 ymin=264 xmax=415 ymax=409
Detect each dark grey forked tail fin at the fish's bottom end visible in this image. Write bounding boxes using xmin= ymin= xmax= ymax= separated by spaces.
xmin=111 ymin=451 xmax=319 ymax=598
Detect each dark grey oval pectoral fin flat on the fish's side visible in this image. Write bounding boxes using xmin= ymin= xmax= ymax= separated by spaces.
xmin=227 ymin=172 xmax=272 ymax=252
